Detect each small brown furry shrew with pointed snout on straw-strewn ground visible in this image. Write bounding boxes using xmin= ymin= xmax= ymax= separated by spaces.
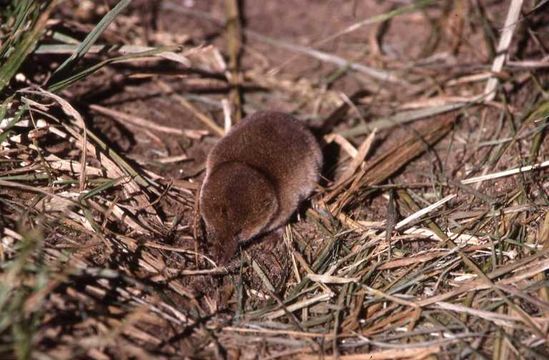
xmin=199 ymin=112 xmax=322 ymax=264
